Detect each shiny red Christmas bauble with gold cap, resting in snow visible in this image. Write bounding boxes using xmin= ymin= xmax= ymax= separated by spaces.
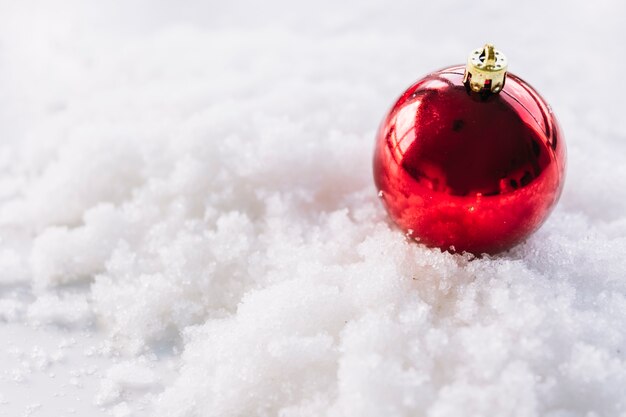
xmin=374 ymin=46 xmax=566 ymax=254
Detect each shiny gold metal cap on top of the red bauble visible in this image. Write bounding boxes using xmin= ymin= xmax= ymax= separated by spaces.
xmin=463 ymin=44 xmax=508 ymax=93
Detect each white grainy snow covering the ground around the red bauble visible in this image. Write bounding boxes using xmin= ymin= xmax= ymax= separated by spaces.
xmin=0 ymin=0 xmax=626 ymax=417
